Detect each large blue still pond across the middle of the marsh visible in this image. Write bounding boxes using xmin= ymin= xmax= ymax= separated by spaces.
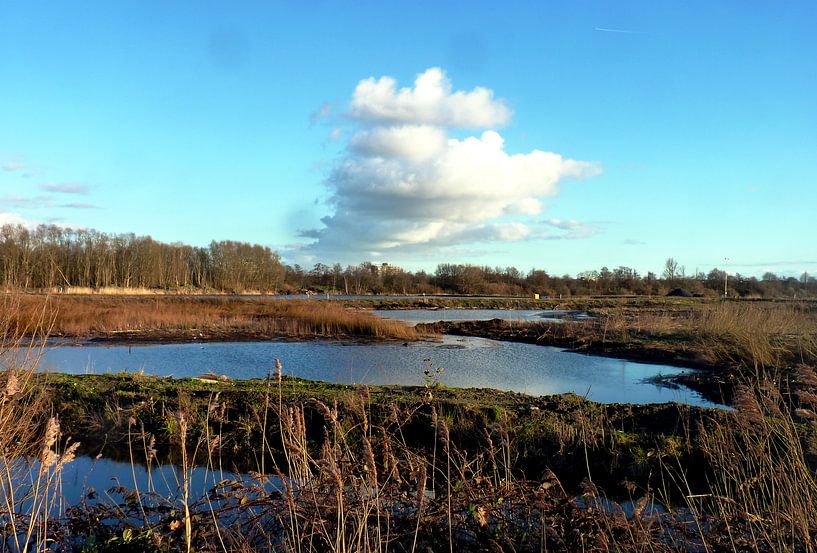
xmin=40 ymin=336 xmax=713 ymax=406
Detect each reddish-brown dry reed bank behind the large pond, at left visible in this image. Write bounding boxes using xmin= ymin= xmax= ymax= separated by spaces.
xmin=4 ymin=295 xmax=428 ymax=341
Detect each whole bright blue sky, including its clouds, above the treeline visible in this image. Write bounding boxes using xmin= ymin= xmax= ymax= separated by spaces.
xmin=0 ymin=0 xmax=817 ymax=275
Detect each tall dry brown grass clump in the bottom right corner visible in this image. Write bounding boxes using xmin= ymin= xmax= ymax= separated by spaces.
xmin=691 ymin=374 xmax=817 ymax=551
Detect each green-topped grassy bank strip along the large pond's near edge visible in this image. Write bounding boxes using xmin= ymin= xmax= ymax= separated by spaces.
xmin=42 ymin=374 xmax=724 ymax=488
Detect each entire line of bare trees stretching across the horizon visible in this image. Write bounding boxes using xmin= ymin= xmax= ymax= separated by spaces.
xmin=0 ymin=225 xmax=817 ymax=298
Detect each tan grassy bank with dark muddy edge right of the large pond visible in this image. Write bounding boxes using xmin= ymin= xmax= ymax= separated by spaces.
xmin=418 ymin=300 xmax=817 ymax=402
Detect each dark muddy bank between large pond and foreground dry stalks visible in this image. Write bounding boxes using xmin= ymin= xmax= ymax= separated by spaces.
xmin=43 ymin=374 xmax=732 ymax=496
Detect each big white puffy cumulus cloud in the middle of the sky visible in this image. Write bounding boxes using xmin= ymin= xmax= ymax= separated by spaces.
xmin=302 ymin=68 xmax=600 ymax=257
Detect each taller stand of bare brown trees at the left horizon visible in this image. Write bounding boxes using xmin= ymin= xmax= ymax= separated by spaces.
xmin=0 ymin=225 xmax=285 ymax=292
